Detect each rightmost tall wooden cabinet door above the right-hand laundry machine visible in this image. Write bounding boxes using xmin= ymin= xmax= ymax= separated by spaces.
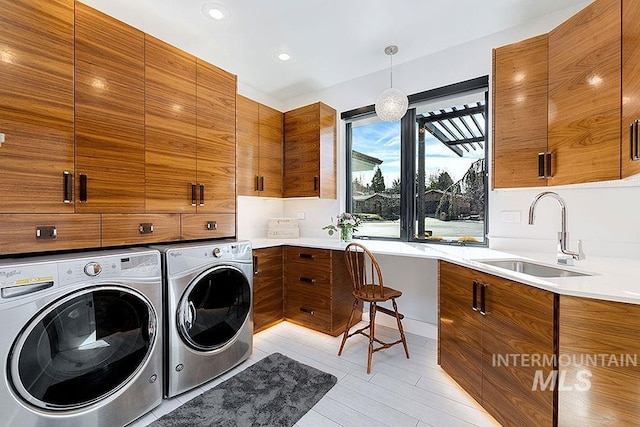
xmin=196 ymin=59 xmax=236 ymax=213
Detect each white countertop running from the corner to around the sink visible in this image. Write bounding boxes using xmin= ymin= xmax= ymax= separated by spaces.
xmin=250 ymin=238 xmax=640 ymax=304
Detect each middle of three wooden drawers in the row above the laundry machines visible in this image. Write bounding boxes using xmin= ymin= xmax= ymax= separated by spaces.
xmin=102 ymin=214 xmax=180 ymax=246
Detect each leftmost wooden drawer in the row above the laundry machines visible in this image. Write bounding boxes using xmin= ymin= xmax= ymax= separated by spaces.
xmin=0 ymin=214 xmax=100 ymax=254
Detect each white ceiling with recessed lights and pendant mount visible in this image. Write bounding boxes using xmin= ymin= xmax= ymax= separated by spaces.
xmin=77 ymin=0 xmax=585 ymax=101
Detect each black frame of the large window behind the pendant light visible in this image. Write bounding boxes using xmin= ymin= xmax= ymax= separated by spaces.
xmin=340 ymin=75 xmax=490 ymax=247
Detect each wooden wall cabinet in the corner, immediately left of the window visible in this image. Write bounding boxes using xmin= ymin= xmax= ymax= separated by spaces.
xmin=283 ymin=102 xmax=336 ymax=199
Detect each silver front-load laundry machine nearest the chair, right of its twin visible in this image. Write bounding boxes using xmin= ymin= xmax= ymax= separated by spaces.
xmin=158 ymin=240 xmax=253 ymax=397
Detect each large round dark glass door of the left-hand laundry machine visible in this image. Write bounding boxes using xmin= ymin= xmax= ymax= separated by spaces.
xmin=9 ymin=286 xmax=157 ymax=411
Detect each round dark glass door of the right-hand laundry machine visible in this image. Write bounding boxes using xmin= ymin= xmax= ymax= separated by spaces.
xmin=176 ymin=265 xmax=251 ymax=351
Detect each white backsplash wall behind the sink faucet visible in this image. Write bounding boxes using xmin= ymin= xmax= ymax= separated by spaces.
xmin=489 ymin=181 xmax=640 ymax=258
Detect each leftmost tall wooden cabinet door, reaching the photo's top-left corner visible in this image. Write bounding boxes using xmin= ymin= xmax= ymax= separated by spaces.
xmin=0 ymin=0 xmax=74 ymax=213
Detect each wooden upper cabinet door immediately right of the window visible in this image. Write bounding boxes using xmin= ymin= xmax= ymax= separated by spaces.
xmin=492 ymin=34 xmax=548 ymax=188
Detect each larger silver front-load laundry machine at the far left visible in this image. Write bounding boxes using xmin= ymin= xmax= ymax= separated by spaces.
xmin=0 ymin=249 xmax=162 ymax=427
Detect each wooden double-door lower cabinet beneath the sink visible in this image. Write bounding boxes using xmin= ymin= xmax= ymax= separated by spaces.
xmin=438 ymin=261 xmax=558 ymax=426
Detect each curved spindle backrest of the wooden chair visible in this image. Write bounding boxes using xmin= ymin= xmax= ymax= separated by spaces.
xmin=344 ymin=243 xmax=384 ymax=298
